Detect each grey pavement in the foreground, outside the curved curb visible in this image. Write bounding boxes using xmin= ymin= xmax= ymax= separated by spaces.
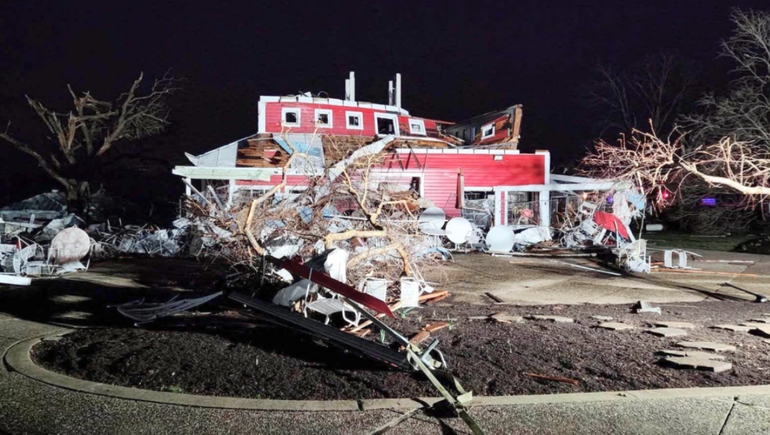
xmin=0 ymin=314 xmax=770 ymax=435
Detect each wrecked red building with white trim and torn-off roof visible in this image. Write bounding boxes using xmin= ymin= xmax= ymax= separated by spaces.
xmin=173 ymin=73 xmax=612 ymax=235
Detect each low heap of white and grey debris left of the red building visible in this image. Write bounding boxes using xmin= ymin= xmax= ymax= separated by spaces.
xmin=0 ymin=190 xmax=201 ymax=285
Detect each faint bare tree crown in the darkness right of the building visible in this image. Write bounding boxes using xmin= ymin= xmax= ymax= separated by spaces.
xmin=588 ymin=53 xmax=693 ymax=139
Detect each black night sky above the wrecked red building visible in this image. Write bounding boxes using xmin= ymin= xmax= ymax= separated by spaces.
xmin=0 ymin=0 xmax=770 ymax=210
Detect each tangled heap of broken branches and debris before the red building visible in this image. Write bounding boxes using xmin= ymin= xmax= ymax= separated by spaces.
xmin=179 ymin=137 xmax=448 ymax=308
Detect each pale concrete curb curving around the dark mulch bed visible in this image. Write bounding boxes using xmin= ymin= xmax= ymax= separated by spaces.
xmin=5 ymin=331 xmax=770 ymax=411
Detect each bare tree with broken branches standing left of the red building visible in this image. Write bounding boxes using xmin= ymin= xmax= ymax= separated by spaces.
xmin=0 ymin=73 xmax=179 ymax=216
